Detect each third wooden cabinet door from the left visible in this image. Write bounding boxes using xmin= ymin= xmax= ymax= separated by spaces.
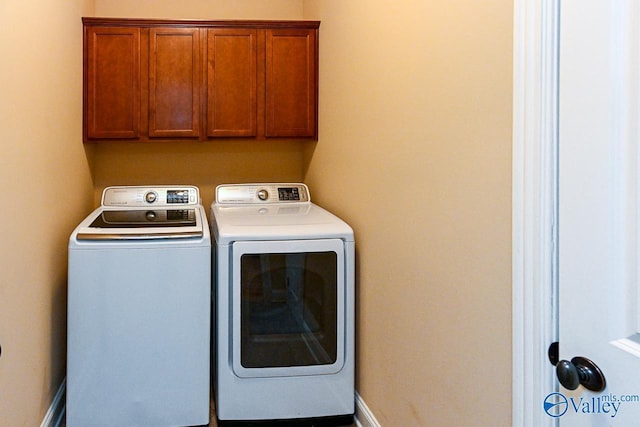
xmin=207 ymin=29 xmax=257 ymax=137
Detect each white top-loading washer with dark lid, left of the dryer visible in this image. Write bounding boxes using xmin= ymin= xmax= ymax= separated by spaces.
xmin=66 ymin=186 xmax=211 ymax=427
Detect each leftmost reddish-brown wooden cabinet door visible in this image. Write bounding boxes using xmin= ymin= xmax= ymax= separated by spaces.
xmin=84 ymin=27 xmax=140 ymax=139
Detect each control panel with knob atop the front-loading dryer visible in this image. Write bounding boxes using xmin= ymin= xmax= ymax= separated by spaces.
xmin=216 ymin=183 xmax=311 ymax=205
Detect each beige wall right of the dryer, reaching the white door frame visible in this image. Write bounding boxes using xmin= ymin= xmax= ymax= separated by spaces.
xmin=304 ymin=0 xmax=513 ymax=427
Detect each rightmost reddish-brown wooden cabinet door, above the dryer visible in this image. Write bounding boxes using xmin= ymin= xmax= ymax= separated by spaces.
xmin=265 ymin=29 xmax=317 ymax=137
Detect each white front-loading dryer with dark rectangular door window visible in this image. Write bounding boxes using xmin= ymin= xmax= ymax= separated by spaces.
xmin=211 ymin=184 xmax=355 ymax=425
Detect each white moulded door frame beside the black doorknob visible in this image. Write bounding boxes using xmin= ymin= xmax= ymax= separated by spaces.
xmin=512 ymin=0 xmax=560 ymax=427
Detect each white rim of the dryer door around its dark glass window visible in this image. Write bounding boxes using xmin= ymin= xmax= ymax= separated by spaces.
xmin=231 ymin=239 xmax=345 ymax=378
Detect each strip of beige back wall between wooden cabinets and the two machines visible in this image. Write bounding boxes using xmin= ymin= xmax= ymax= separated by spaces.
xmin=93 ymin=141 xmax=305 ymax=214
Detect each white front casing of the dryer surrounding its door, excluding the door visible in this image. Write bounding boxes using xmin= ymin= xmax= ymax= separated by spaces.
xmin=212 ymin=239 xmax=355 ymax=421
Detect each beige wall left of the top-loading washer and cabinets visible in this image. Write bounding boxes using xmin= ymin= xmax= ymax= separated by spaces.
xmin=0 ymin=0 xmax=93 ymax=426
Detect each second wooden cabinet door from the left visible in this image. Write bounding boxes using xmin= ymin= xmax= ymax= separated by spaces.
xmin=149 ymin=28 xmax=201 ymax=137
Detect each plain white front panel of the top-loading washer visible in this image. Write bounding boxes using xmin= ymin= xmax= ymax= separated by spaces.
xmin=67 ymin=239 xmax=211 ymax=427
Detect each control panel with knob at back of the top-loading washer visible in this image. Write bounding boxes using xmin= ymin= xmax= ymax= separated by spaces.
xmin=102 ymin=185 xmax=200 ymax=207
